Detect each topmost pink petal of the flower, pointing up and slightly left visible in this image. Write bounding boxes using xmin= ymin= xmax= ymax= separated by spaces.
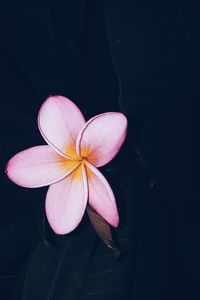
xmin=38 ymin=96 xmax=85 ymax=158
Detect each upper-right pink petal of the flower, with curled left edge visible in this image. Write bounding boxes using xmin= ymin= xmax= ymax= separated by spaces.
xmin=76 ymin=112 xmax=127 ymax=167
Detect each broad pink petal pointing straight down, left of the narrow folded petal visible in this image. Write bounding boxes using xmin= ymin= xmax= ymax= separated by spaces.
xmin=46 ymin=164 xmax=88 ymax=234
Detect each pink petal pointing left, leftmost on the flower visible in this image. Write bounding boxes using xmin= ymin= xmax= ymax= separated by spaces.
xmin=6 ymin=145 xmax=78 ymax=188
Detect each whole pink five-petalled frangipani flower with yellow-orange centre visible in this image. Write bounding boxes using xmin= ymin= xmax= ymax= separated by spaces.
xmin=6 ymin=96 xmax=127 ymax=234
